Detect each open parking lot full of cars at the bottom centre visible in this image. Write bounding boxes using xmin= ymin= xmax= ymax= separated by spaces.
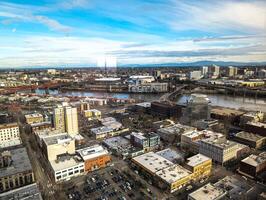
xmin=65 ymin=167 xmax=151 ymax=200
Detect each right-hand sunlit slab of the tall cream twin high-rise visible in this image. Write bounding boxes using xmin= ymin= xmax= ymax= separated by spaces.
xmin=65 ymin=106 xmax=79 ymax=135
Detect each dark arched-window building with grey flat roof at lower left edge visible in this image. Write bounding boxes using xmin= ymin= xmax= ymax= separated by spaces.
xmin=0 ymin=148 xmax=34 ymax=193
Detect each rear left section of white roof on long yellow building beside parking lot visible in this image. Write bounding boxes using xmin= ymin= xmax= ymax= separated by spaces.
xmin=132 ymin=152 xmax=174 ymax=173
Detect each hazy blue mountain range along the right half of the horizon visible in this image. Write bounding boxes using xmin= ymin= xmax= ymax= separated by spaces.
xmin=119 ymin=60 xmax=266 ymax=67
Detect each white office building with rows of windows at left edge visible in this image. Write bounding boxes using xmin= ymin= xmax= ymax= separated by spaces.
xmin=0 ymin=123 xmax=21 ymax=148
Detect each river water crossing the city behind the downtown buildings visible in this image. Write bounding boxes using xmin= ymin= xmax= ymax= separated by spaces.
xmin=36 ymin=89 xmax=266 ymax=112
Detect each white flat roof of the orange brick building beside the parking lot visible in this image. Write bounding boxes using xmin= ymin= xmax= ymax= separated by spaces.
xmin=77 ymin=145 xmax=108 ymax=160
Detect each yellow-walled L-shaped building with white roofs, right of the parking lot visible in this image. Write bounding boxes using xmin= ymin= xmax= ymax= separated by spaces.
xmin=132 ymin=152 xmax=212 ymax=193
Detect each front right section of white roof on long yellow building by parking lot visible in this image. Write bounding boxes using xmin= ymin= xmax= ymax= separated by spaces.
xmin=156 ymin=165 xmax=192 ymax=184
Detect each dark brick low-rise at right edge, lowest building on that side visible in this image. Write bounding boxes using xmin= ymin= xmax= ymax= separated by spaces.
xmin=239 ymin=152 xmax=266 ymax=178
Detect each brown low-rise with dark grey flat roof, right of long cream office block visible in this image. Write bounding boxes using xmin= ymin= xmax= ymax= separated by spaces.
xmin=233 ymin=131 xmax=266 ymax=149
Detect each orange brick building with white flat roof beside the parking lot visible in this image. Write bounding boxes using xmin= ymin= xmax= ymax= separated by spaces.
xmin=77 ymin=145 xmax=111 ymax=172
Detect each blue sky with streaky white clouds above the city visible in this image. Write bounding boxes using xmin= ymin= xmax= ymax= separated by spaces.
xmin=0 ymin=0 xmax=266 ymax=68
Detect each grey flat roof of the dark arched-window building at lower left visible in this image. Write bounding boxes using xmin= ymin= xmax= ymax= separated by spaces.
xmin=0 ymin=147 xmax=32 ymax=178
